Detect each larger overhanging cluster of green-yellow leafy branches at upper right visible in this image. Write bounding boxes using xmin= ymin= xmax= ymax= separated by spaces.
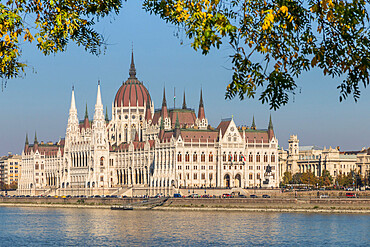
xmin=144 ymin=0 xmax=370 ymax=109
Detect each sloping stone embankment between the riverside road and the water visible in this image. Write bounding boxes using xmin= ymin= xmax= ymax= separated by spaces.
xmin=0 ymin=198 xmax=370 ymax=214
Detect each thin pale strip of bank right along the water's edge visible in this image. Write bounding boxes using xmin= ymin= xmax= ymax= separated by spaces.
xmin=0 ymin=202 xmax=370 ymax=215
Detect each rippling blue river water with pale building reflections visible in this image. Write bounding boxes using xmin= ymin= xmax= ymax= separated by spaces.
xmin=0 ymin=207 xmax=370 ymax=246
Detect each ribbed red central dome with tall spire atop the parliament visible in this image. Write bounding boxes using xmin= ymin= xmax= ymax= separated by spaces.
xmin=114 ymin=53 xmax=151 ymax=107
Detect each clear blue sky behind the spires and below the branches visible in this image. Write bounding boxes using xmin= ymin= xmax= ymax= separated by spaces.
xmin=0 ymin=1 xmax=370 ymax=155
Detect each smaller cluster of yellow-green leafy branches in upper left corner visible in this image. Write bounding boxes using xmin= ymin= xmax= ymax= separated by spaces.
xmin=0 ymin=0 xmax=122 ymax=79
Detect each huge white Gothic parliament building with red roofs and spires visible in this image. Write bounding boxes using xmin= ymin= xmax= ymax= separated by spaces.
xmin=18 ymin=54 xmax=280 ymax=196
